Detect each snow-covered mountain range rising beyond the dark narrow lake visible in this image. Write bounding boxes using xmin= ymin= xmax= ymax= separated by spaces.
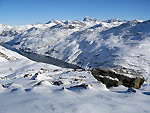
xmin=0 ymin=17 xmax=150 ymax=77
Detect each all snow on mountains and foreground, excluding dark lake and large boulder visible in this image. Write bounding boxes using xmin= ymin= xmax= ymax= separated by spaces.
xmin=0 ymin=17 xmax=150 ymax=113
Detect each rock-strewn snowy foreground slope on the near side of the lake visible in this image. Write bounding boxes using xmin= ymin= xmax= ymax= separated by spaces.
xmin=0 ymin=46 xmax=150 ymax=113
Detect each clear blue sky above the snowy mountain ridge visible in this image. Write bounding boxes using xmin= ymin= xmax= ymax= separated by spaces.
xmin=0 ymin=0 xmax=150 ymax=25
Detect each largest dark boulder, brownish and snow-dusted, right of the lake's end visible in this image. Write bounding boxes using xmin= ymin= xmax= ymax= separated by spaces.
xmin=91 ymin=68 xmax=145 ymax=89
